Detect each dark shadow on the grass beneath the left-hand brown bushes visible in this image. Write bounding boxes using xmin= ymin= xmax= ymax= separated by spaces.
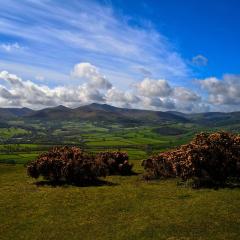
xmin=34 ymin=179 xmax=119 ymax=187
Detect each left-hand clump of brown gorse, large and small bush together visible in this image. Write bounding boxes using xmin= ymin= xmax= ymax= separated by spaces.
xmin=27 ymin=147 xmax=132 ymax=183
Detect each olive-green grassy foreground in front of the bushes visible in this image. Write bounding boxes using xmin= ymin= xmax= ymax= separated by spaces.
xmin=0 ymin=161 xmax=240 ymax=240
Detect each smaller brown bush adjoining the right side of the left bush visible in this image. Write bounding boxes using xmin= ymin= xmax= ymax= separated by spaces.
xmin=96 ymin=151 xmax=133 ymax=175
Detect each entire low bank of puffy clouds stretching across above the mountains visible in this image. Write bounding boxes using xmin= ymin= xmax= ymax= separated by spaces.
xmin=0 ymin=63 xmax=234 ymax=112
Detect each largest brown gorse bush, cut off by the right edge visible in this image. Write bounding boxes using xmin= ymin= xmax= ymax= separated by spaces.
xmin=142 ymin=132 xmax=240 ymax=187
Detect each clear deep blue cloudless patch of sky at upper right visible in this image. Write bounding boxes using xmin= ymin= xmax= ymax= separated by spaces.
xmin=117 ymin=0 xmax=240 ymax=77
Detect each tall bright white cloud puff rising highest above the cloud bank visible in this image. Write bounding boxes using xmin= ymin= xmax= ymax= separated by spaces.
xmin=71 ymin=63 xmax=112 ymax=89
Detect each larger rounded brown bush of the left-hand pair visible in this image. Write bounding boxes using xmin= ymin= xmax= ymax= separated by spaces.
xmin=27 ymin=147 xmax=107 ymax=183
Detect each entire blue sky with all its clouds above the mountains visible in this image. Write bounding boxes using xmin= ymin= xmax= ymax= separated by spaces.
xmin=0 ymin=0 xmax=240 ymax=112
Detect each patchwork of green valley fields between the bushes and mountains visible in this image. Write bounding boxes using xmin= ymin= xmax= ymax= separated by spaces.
xmin=0 ymin=121 xmax=218 ymax=163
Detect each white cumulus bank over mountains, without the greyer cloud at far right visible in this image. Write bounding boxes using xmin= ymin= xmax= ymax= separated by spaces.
xmin=0 ymin=67 xmax=200 ymax=111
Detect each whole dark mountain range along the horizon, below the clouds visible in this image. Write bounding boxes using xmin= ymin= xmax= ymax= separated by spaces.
xmin=0 ymin=103 xmax=240 ymax=126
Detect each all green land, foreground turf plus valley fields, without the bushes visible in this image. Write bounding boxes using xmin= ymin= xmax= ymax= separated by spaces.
xmin=0 ymin=121 xmax=240 ymax=240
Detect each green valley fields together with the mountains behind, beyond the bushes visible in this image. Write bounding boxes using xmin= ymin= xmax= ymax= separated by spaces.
xmin=0 ymin=104 xmax=240 ymax=163
